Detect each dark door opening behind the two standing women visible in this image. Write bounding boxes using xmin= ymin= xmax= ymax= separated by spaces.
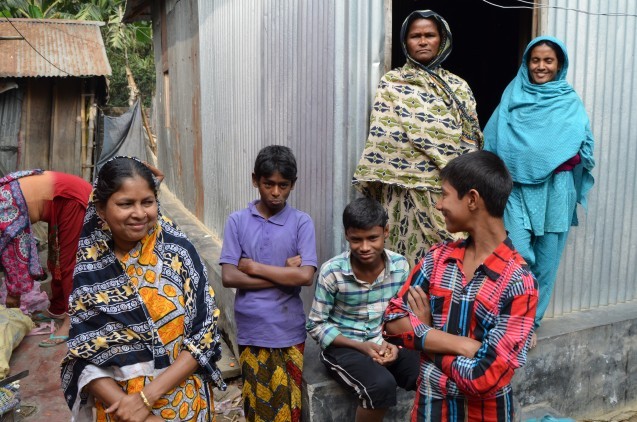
xmin=391 ymin=0 xmax=533 ymax=128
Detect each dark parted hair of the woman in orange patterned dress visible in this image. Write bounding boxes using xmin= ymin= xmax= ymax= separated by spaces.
xmin=94 ymin=157 xmax=157 ymax=204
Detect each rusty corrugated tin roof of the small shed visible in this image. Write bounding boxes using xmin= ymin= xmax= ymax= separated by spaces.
xmin=0 ymin=18 xmax=111 ymax=77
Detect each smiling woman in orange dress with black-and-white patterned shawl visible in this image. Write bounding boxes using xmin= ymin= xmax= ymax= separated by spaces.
xmin=62 ymin=157 xmax=224 ymax=421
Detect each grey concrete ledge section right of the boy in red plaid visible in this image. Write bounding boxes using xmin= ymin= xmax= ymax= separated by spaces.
xmin=513 ymin=301 xmax=637 ymax=418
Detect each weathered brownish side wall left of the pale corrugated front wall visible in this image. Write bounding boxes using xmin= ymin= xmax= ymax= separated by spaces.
xmin=153 ymin=0 xmax=203 ymax=219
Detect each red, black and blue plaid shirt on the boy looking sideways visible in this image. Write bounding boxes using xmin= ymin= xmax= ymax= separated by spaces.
xmin=385 ymin=238 xmax=538 ymax=421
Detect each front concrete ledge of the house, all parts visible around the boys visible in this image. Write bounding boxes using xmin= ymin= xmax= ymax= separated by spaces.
xmin=303 ymin=302 xmax=637 ymax=422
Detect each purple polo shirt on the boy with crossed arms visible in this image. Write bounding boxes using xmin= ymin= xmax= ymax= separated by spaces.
xmin=219 ymin=200 xmax=317 ymax=348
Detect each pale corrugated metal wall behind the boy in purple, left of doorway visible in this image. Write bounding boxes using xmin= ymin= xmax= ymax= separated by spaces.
xmin=199 ymin=0 xmax=384 ymax=303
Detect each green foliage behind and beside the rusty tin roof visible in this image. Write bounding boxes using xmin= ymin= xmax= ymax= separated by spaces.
xmin=0 ymin=0 xmax=155 ymax=107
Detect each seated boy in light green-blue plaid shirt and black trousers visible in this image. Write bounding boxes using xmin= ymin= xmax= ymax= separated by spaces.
xmin=306 ymin=198 xmax=419 ymax=422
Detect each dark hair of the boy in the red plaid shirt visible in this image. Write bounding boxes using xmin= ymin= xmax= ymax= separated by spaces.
xmin=440 ymin=151 xmax=513 ymax=217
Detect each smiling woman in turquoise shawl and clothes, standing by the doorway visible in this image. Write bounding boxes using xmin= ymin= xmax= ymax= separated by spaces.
xmin=484 ymin=37 xmax=595 ymax=329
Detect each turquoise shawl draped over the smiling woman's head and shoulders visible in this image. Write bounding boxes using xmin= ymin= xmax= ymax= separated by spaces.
xmin=484 ymin=36 xmax=595 ymax=209
